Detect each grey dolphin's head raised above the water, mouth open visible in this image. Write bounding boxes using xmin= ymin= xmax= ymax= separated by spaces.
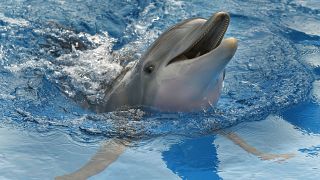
xmin=95 ymin=12 xmax=237 ymax=112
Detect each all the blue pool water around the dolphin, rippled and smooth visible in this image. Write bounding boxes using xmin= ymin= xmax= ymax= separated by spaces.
xmin=0 ymin=0 xmax=320 ymax=179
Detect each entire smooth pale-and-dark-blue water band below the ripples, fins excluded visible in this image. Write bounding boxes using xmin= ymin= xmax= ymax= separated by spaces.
xmin=0 ymin=104 xmax=320 ymax=180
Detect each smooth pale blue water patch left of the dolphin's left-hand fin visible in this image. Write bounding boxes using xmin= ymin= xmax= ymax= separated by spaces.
xmin=0 ymin=127 xmax=99 ymax=180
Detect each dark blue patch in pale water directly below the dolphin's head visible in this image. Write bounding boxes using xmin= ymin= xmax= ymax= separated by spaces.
xmin=162 ymin=136 xmax=219 ymax=179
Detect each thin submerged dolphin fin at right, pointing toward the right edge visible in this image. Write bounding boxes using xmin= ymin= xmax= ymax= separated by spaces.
xmin=218 ymin=130 xmax=295 ymax=162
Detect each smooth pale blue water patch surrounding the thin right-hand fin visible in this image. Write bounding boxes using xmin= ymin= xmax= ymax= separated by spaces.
xmin=214 ymin=114 xmax=320 ymax=179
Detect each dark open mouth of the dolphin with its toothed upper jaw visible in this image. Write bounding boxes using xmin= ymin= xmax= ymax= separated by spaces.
xmin=167 ymin=12 xmax=230 ymax=65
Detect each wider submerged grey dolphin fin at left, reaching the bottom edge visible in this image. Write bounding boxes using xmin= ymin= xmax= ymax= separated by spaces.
xmin=55 ymin=139 xmax=129 ymax=180
